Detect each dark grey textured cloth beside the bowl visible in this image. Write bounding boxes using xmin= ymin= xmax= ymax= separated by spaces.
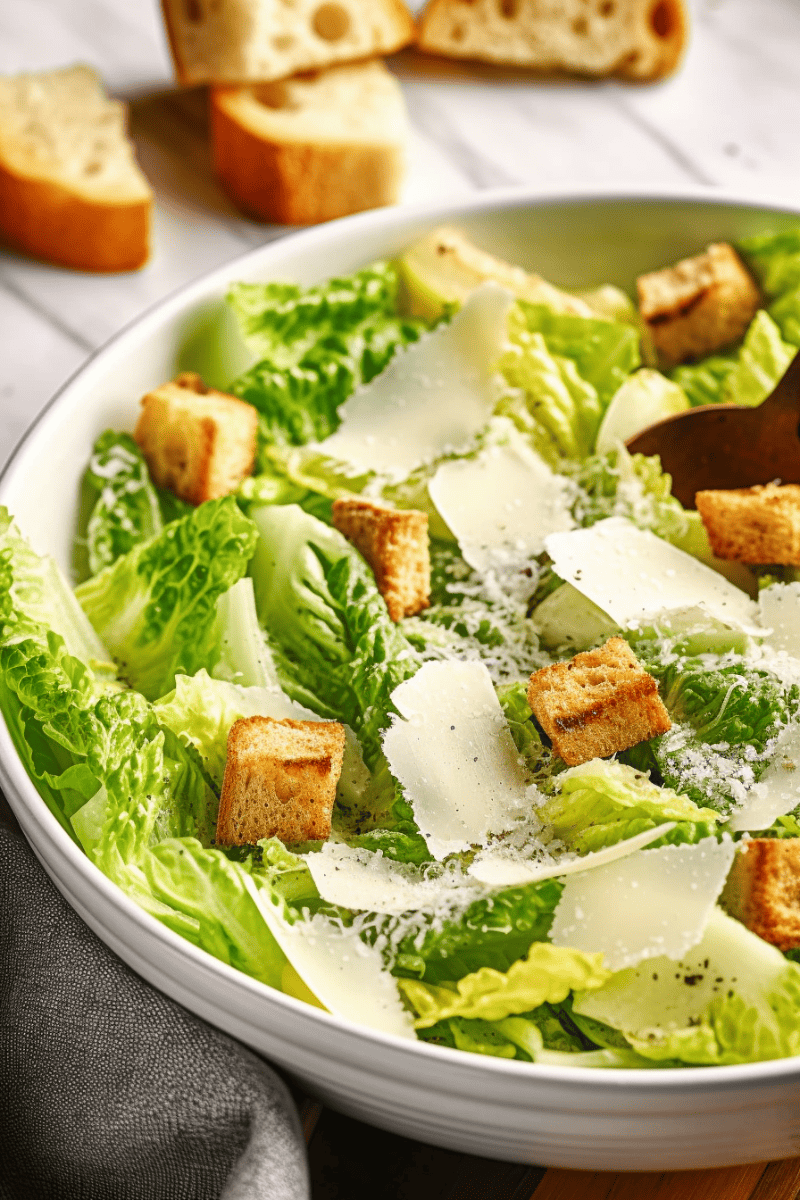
xmin=0 ymin=827 xmax=308 ymax=1200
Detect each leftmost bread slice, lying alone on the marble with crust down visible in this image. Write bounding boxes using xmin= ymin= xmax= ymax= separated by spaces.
xmin=0 ymin=66 xmax=152 ymax=271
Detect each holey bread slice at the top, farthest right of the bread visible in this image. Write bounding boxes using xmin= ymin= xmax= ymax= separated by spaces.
xmin=419 ymin=0 xmax=686 ymax=80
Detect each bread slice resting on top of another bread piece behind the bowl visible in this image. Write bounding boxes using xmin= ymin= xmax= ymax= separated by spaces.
xmin=162 ymin=0 xmax=415 ymax=85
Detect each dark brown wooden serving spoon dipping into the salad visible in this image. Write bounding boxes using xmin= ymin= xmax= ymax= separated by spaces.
xmin=626 ymin=352 xmax=800 ymax=509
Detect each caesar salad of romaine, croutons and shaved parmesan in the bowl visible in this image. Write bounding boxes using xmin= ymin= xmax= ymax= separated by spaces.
xmin=0 ymin=220 xmax=800 ymax=1068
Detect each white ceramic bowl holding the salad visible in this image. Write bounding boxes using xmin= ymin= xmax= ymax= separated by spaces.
xmin=0 ymin=190 xmax=800 ymax=1170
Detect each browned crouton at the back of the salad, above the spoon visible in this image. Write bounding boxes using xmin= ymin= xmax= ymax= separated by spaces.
xmin=637 ymin=242 xmax=762 ymax=367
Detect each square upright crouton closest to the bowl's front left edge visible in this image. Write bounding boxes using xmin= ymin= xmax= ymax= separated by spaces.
xmin=217 ymin=716 xmax=344 ymax=846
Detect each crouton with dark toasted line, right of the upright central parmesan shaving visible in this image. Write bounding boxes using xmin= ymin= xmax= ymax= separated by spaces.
xmin=528 ymin=637 xmax=672 ymax=767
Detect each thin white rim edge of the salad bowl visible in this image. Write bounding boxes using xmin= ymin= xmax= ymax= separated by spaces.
xmin=0 ymin=182 xmax=800 ymax=1106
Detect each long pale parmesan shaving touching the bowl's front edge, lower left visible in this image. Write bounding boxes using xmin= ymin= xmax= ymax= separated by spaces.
xmin=245 ymin=877 xmax=416 ymax=1038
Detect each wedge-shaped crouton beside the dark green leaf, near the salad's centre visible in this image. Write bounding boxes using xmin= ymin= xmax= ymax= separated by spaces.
xmin=333 ymin=499 xmax=431 ymax=620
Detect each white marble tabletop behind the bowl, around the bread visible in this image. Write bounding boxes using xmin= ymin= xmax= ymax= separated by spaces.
xmin=0 ymin=0 xmax=800 ymax=461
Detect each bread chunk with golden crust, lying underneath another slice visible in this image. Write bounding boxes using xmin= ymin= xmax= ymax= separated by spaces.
xmin=211 ymin=61 xmax=408 ymax=224
